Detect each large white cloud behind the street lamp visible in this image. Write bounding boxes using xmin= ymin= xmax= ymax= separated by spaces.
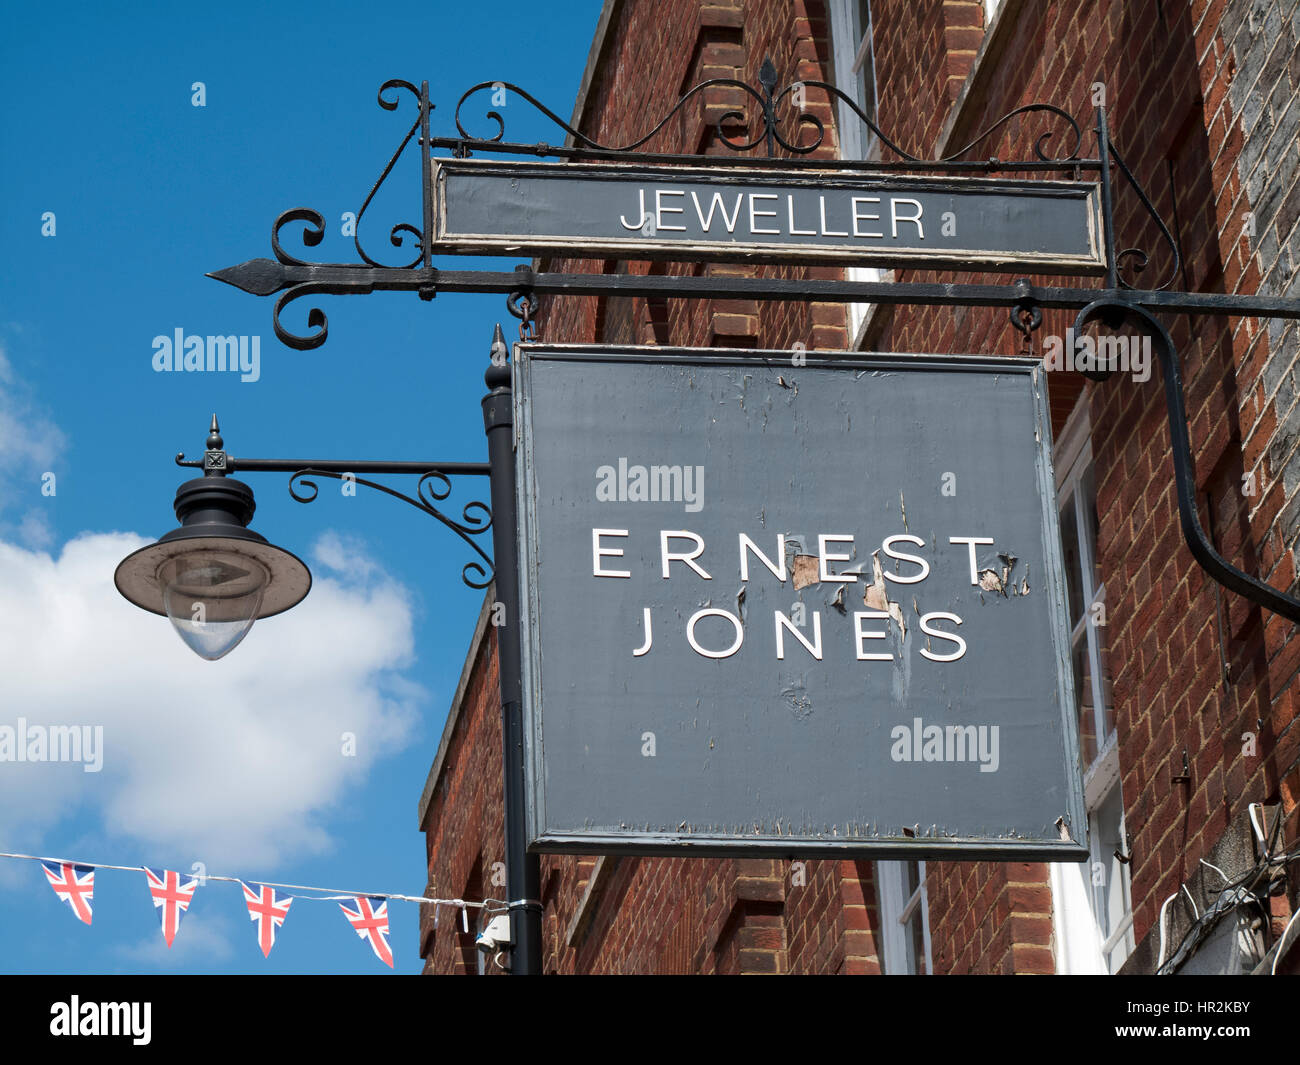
xmin=0 ymin=533 xmax=425 ymax=875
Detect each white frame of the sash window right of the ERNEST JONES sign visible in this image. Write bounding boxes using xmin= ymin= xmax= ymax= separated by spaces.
xmin=1049 ymin=392 xmax=1135 ymax=975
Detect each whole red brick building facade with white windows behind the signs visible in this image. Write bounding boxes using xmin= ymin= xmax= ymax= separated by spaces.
xmin=420 ymin=0 xmax=1300 ymax=973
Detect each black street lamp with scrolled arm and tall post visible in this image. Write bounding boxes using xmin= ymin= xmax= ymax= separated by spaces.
xmin=113 ymin=332 xmax=542 ymax=974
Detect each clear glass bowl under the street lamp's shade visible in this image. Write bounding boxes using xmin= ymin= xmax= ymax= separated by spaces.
xmin=157 ymin=549 xmax=270 ymax=662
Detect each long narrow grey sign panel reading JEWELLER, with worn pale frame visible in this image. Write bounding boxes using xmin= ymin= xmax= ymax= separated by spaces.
xmin=433 ymin=159 xmax=1105 ymax=274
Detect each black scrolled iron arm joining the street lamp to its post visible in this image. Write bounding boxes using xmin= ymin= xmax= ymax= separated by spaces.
xmin=176 ymin=444 xmax=494 ymax=588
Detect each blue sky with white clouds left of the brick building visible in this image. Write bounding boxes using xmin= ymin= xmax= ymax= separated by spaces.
xmin=0 ymin=0 xmax=599 ymax=973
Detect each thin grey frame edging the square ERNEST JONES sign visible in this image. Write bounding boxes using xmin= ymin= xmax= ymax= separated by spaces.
xmin=512 ymin=343 xmax=1088 ymax=862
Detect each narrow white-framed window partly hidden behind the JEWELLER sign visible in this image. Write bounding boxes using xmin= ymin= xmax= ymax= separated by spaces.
xmin=829 ymin=0 xmax=881 ymax=347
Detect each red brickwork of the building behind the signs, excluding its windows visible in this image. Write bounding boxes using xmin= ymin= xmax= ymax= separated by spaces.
xmin=424 ymin=0 xmax=1300 ymax=973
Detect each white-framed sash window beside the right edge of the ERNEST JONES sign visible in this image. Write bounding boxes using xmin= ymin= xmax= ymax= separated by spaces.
xmin=1050 ymin=386 xmax=1134 ymax=973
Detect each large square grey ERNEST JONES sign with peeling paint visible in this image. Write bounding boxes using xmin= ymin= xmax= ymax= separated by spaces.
xmin=515 ymin=345 xmax=1086 ymax=861
